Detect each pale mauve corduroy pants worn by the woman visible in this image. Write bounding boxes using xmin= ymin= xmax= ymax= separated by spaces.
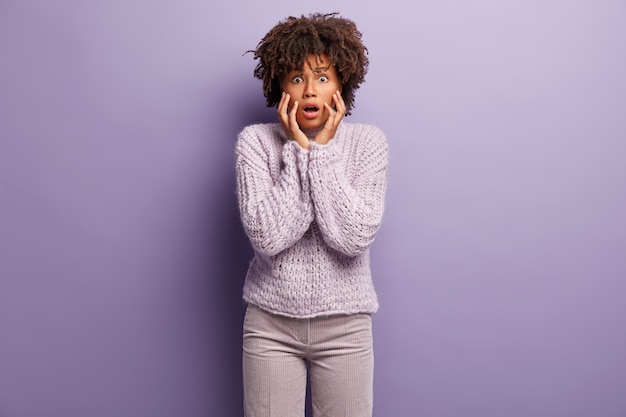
xmin=243 ymin=304 xmax=374 ymax=417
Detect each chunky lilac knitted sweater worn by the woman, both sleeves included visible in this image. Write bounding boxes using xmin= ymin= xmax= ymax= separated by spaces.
xmin=236 ymin=121 xmax=388 ymax=318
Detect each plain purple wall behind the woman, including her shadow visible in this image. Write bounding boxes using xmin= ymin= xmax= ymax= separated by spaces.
xmin=0 ymin=0 xmax=626 ymax=417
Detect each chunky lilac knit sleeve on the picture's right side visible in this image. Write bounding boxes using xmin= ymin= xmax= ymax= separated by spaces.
xmin=309 ymin=123 xmax=388 ymax=256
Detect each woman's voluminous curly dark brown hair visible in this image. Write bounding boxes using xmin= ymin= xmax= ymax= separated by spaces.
xmin=248 ymin=13 xmax=369 ymax=115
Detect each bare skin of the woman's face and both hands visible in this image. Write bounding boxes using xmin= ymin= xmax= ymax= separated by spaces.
xmin=277 ymin=54 xmax=346 ymax=149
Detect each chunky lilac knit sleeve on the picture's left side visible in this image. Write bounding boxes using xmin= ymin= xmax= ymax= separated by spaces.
xmin=235 ymin=128 xmax=314 ymax=256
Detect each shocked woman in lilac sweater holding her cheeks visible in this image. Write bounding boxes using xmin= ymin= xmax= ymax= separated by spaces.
xmin=236 ymin=13 xmax=388 ymax=417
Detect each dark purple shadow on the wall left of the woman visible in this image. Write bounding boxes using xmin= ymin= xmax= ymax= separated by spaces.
xmin=202 ymin=92 xmax=276 ymax=417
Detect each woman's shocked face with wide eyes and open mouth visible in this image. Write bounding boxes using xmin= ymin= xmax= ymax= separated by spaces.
xmin=281 ymin=54 xmax=341 ymax=129
